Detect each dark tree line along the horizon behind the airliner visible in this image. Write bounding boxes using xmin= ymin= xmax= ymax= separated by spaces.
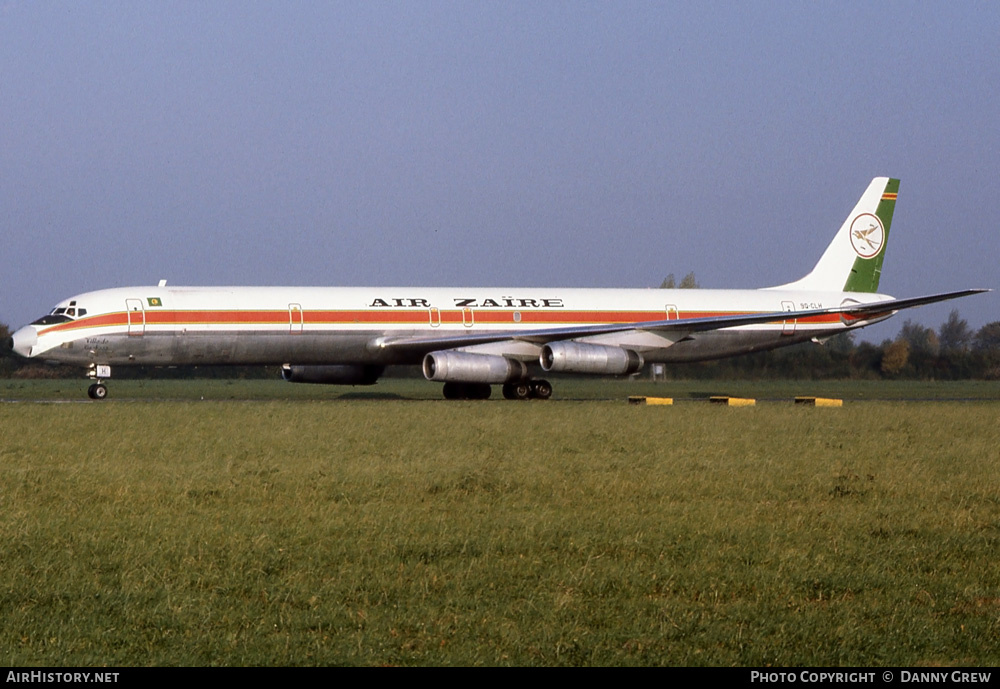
xmin=0 ymin=312 xmax=1000 ymax=380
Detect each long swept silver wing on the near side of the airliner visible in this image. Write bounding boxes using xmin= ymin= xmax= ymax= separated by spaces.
xmin=376 ymin=289 xmax=991 ymax=353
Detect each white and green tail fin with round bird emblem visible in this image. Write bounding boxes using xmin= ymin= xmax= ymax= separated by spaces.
xmin=772 ymin=177 xmax=899 ymax=292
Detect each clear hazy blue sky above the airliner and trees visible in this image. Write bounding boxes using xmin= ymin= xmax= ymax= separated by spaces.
xmin=0 ymin=0 xmax=1000 ymax=339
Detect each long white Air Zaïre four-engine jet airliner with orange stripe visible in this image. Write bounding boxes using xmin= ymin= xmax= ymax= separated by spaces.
xmin=8 ymin=177 xmax=989 ymax=399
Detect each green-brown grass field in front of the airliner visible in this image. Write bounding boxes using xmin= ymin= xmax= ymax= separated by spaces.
xmin=0 ymin=381 xmax=1000 ymax=666
